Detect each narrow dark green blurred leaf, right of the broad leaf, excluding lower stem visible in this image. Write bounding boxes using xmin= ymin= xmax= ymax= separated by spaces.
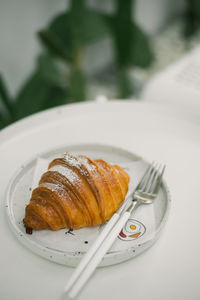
xmin=105 ymin=0 xmax=153 ymax=69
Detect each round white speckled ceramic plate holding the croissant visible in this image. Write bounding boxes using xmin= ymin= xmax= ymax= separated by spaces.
xmin=5 ymin=144 xmax=170 ymax=266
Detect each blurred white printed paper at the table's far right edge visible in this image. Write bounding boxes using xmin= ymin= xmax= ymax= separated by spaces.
xmin=141 ymin=46 xmax=200 ymax=120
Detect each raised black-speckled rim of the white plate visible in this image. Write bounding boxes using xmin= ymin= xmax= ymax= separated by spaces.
xmin=5 ymin=143 xmax=171 ymax=267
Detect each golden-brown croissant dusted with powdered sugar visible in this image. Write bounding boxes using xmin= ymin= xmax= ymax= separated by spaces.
xmin=23 ymin=153 xmax=129 ymax=231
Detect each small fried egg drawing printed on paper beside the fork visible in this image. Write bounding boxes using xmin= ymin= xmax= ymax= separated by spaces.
xmin=118 ymin=219 xmax=146 ymax=241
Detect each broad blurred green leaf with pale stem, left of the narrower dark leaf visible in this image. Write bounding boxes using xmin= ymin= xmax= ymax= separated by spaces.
xmin=39 ymin=0 xmax=108 ymax=102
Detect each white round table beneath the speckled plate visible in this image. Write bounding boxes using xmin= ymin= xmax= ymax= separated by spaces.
xmin=0 ymin=101 xmax=200 ymax=300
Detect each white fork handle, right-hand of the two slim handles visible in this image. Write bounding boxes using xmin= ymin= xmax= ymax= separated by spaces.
xmin=67 ymin=201 xmax=136 ymax=299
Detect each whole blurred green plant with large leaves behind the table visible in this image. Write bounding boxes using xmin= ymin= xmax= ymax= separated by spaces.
xmin=0 ymin=0 xmax=153 ymax=128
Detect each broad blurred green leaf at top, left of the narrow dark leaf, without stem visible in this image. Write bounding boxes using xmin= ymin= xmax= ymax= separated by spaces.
xmin=39 ymin=6 xmax=109 ymax=61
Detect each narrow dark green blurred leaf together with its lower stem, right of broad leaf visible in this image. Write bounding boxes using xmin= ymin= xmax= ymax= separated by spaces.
xmin=103 ymin=0 xmax=153 ymax=98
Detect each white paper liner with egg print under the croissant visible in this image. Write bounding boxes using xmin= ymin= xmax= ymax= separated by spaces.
xmin=33 ymin=158 xmax=155 ymax=252
